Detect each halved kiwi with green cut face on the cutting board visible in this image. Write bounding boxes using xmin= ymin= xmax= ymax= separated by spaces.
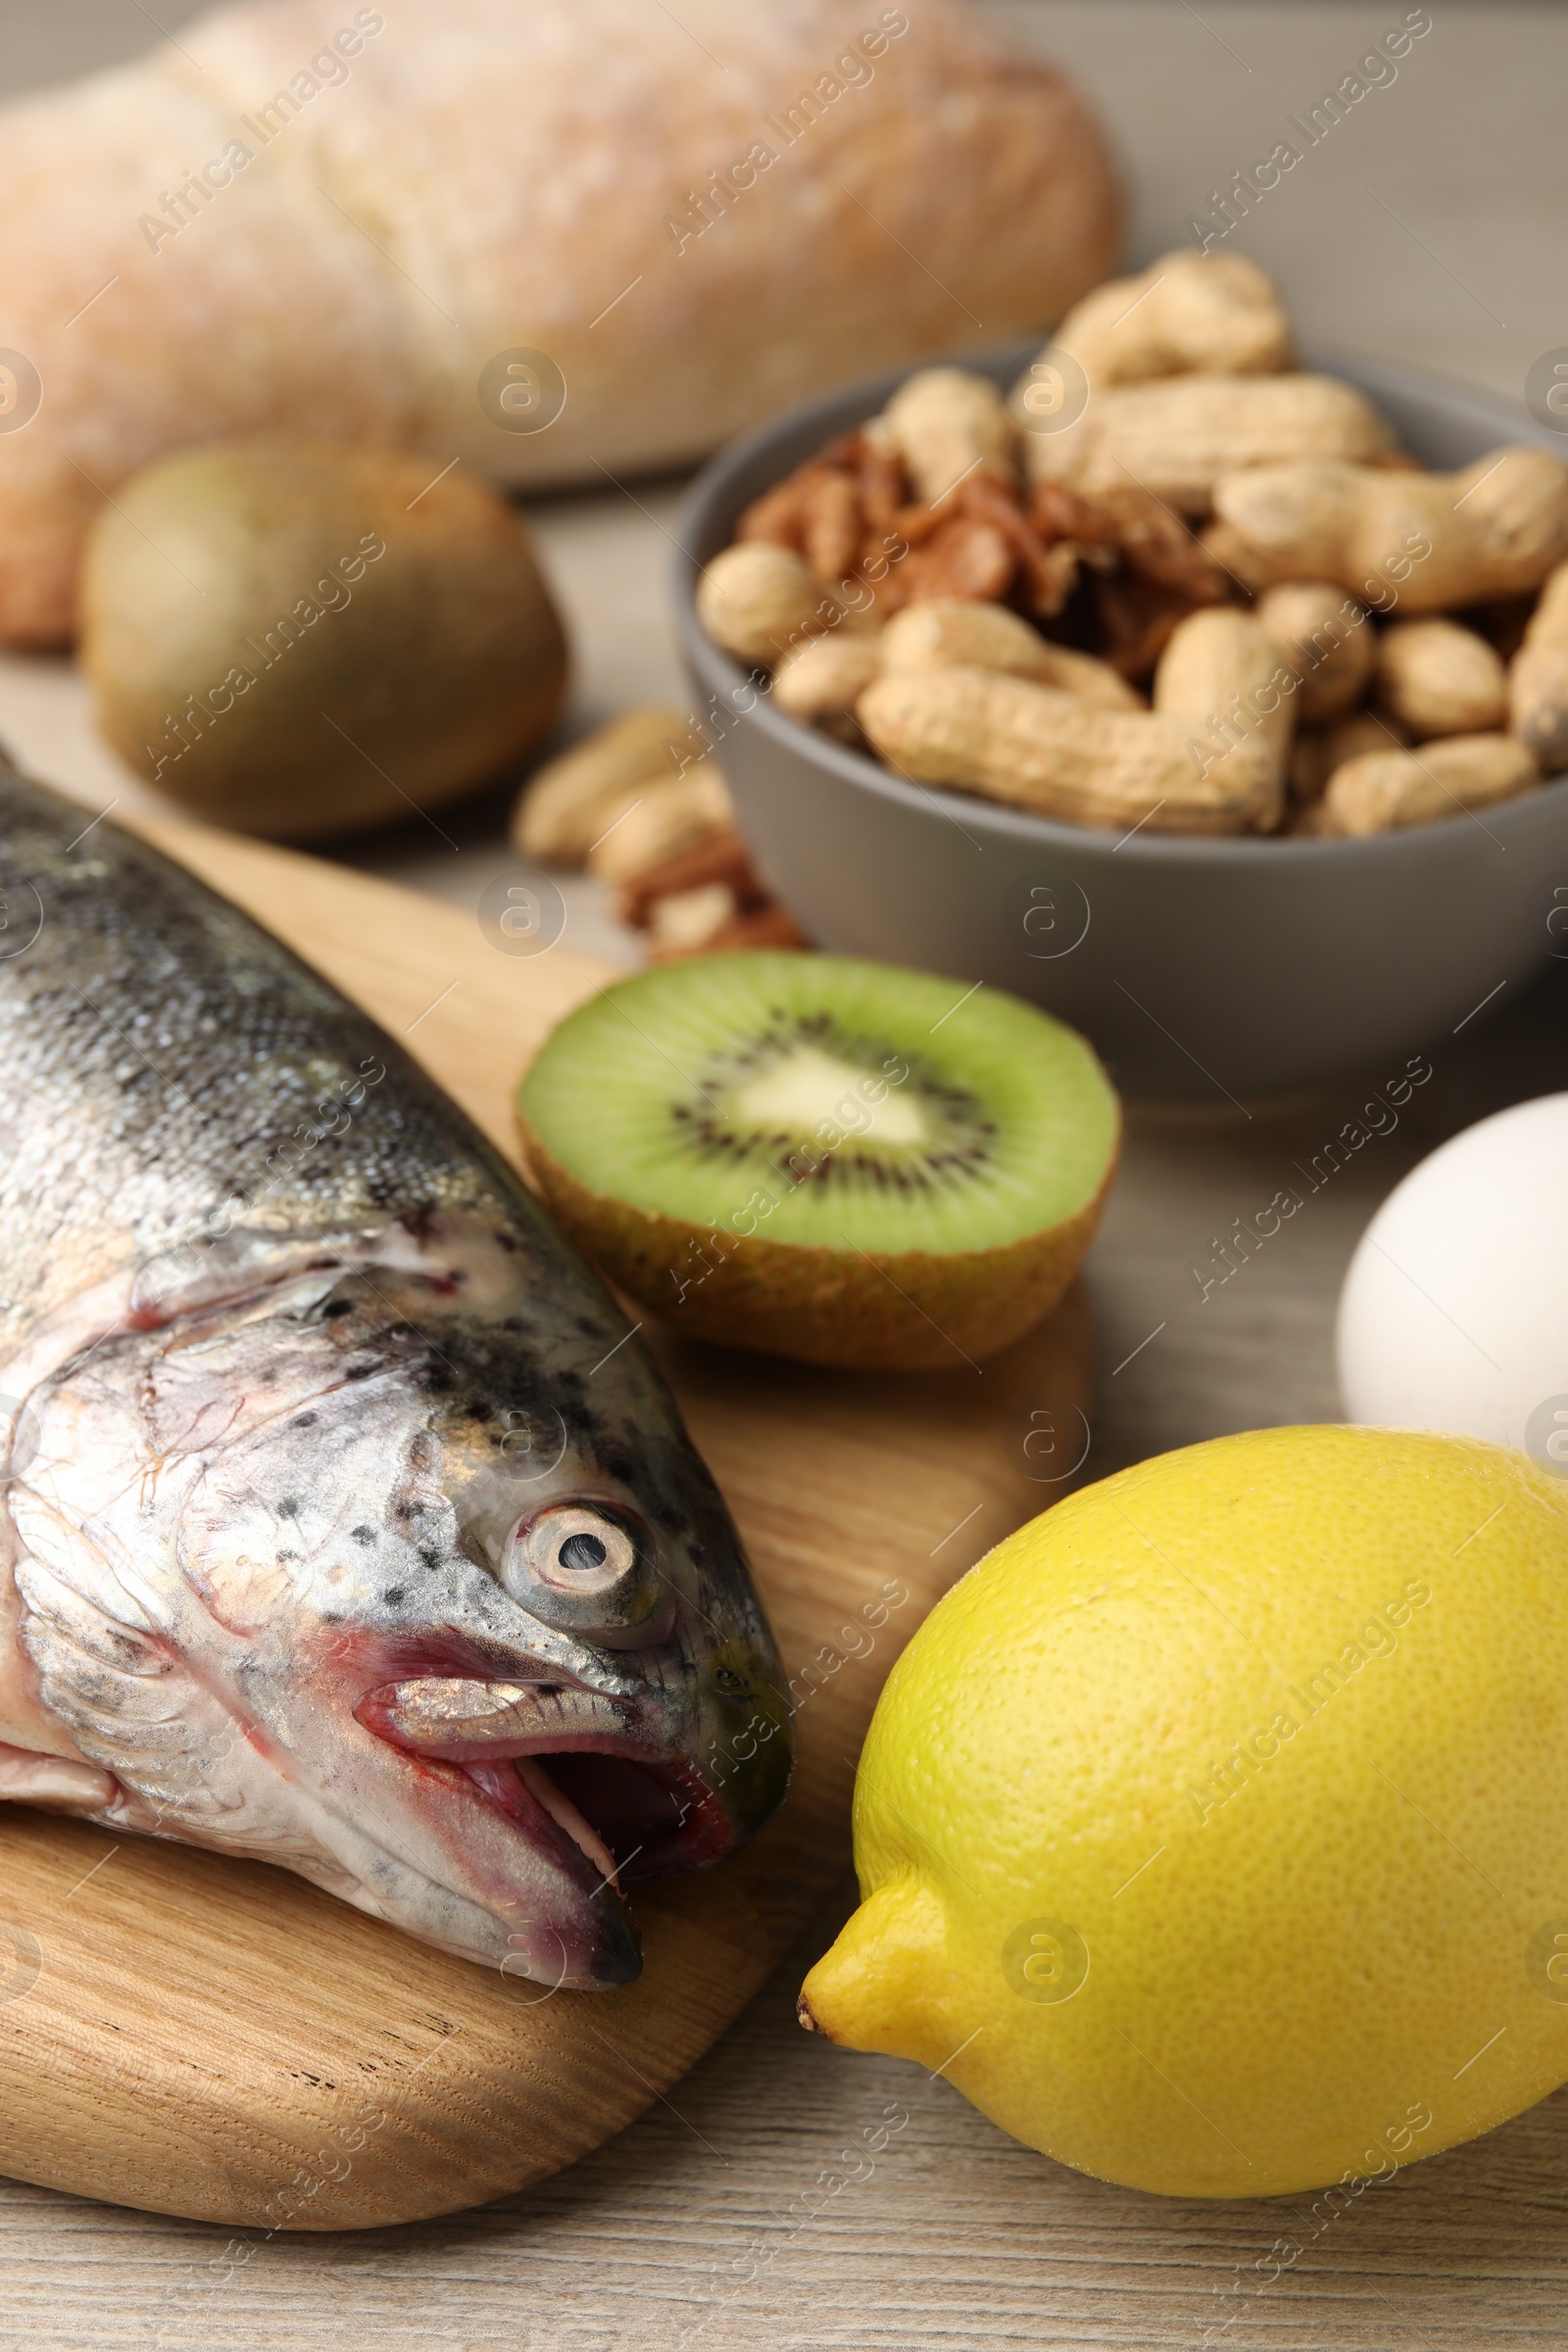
xmin=517 ymin=953 xmax=1119 ymax=1369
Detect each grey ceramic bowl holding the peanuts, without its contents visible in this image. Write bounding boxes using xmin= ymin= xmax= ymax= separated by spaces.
xmin=674 ymin=343 xmax=1568 ymax=1101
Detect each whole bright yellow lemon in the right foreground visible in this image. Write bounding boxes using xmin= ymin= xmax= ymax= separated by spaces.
xmin=802 ymin=1428 xmax=1568 ymax=2197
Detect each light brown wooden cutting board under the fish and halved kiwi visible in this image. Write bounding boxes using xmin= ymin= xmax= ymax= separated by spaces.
xmin=0 ymin=825 xmax=1089 ymax=2232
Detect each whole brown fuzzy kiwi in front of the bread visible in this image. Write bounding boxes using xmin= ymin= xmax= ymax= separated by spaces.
xmin=80 ymin=440 xmax=566 ymax=842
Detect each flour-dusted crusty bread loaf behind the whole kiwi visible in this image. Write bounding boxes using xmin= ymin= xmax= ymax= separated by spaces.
xmin=0 ymin=0 xmax=1116 ymax=642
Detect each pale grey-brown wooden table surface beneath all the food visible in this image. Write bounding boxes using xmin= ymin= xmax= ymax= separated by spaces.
xmin=0 ymin=0 xmax=1568 ymax=2352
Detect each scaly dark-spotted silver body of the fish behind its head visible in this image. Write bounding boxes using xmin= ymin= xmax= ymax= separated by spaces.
xmin=0 ymin=771 xmax=597 ymax=1343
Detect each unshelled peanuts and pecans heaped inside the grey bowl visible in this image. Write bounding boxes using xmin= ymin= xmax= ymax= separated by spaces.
xmin=698 ymin=252 xmax=1568 ymax=837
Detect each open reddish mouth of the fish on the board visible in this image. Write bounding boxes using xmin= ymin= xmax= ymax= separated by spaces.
xmin=353 ymin=1675 xmax=748 ymax=1983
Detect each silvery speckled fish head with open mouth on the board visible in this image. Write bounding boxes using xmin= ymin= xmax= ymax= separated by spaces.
xmin=14 ymin=1223 xmax=792 ymax=1989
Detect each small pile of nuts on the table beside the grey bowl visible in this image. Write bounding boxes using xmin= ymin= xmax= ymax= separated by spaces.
xmin=513 ymin=704 xmax=807 ymax=962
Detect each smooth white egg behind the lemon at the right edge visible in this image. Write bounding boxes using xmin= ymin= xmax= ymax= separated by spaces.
xmin=1338 ymin=1094 xmax=1568 ymax=1475
